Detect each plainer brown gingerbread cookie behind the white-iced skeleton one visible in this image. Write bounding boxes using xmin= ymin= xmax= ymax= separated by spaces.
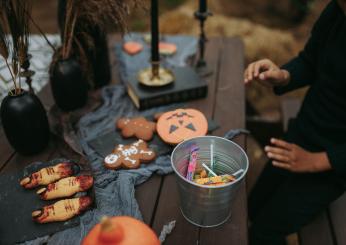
xmin=116 ymin=117 xmax=156 ymax=141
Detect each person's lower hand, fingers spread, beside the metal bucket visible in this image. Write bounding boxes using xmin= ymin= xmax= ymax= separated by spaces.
xmin=264 ymin=139 xmax=331 ymax=173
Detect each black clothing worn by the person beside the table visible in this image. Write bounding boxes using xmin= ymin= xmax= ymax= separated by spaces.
xmin=249 ymin=1 xmax=346 ymax=245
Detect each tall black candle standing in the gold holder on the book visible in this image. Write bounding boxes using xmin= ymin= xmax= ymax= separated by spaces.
xmin=151 ymin=0 xmax=160 ymax=62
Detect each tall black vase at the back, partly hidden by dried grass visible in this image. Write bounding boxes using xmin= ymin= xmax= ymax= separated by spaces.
xmin=58 ymin=0 xmax=111 ymax=88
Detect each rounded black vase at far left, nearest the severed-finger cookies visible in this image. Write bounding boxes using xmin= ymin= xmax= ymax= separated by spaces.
xmin=0 ymin=90 xmax=50 ymax=155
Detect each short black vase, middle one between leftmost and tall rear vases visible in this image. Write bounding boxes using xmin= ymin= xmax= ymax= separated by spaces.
xmin=50 ymin=58 xmax=89 ymax=111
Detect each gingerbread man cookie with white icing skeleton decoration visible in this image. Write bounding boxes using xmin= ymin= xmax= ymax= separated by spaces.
xmin=104 ymin=140 xmax=156 ymax=169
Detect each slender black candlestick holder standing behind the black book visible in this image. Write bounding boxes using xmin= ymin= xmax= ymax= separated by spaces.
xmin=195 ymin=11 xmax=213 ymax=76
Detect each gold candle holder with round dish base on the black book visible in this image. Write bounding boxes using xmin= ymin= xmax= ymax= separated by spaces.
xmin=138 ymin=62 xmax=175 ymax=87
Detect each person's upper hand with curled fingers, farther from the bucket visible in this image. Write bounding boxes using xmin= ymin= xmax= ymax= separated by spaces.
xmin=244 ymin=59 xmax=290 ymax=87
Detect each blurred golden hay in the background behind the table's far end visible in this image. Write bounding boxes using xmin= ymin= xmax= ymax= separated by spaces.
xmin=160 ymin=1 xmax=300 ymax=64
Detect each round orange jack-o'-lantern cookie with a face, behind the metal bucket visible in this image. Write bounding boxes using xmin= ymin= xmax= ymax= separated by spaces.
xmin=156 ymin=109 xmax=208 ymax=145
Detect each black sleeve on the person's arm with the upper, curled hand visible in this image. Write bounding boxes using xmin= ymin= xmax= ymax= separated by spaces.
xmin=274 ymin=1 xmax=339 ymax=95
